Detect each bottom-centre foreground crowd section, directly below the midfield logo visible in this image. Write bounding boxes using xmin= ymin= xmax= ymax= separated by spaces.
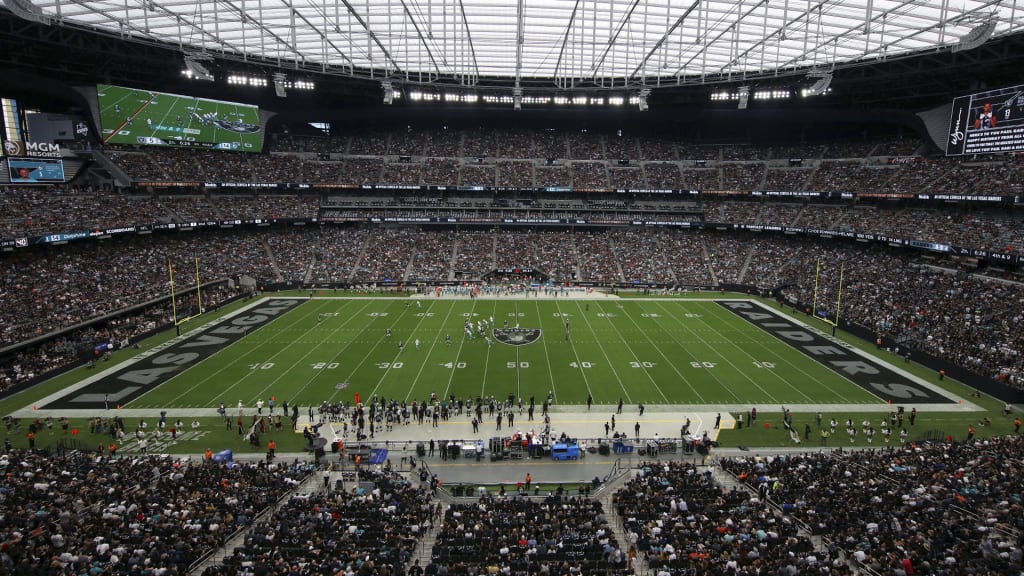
xmin=427 ymin=494 xmax=633 ymax=576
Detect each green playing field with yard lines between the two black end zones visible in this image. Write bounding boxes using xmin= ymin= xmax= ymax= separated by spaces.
xmin=125 ymin=298 xmax=901 ymax=409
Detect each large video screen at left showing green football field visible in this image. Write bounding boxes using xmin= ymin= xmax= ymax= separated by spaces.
xmin=96 ymin=84 xmax=263 ymax=152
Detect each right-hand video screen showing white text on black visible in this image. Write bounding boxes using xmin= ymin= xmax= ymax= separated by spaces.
xmin=946 ymin=86 xmax=1024 ymax=156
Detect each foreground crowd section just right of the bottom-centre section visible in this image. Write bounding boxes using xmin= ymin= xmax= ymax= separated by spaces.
xmin=612 ymin=461 xmax=835 ymax=576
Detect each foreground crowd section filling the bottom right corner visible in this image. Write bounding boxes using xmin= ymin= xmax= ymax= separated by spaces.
xmin=721 ymin=436 xmax=1024 ymax=575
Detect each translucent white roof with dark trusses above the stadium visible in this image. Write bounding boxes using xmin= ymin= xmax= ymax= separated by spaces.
xmin=18 ymin=0 xmax=1024 ymax=88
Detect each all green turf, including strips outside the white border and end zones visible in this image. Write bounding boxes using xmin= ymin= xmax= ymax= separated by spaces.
xmin=6 ymin=292 xmax=1013 ymax=453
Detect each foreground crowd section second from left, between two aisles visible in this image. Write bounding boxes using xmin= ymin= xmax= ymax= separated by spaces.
xmin=203 ymin=468 xmax=434 ymax=576
